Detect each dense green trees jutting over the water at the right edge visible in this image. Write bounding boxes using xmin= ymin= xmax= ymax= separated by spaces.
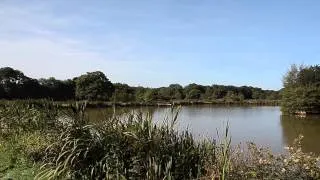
xmin=282 ymin=65 xmax=320 ymax=113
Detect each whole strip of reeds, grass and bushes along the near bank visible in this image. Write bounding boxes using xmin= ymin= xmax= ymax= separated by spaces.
xmin=0 ymin=102 xmax=320 ymax=179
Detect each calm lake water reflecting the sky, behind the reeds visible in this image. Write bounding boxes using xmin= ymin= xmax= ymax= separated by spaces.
xmin=89 ymin=105 xmax=320 ymax=154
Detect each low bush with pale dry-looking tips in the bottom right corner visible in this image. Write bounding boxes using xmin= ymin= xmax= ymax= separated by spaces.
xmin=216 ymin=135 xmax=320 ymax=179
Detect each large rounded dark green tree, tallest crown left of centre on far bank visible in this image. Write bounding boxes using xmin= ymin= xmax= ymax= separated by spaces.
xmin=75 ymin=71 xmax=114 ymax=100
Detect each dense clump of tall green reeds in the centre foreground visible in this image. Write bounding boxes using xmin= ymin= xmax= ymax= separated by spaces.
xmin=37 ymin=106 xmax=214 ymax=179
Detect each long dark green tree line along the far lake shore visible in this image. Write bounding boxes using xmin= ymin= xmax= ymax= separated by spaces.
xmin=0 ymin=67 xmax=280 ymax=102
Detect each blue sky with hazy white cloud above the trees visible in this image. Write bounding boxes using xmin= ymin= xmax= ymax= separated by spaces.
xmin=0 ymin=0 xmax=320 ymax=90
